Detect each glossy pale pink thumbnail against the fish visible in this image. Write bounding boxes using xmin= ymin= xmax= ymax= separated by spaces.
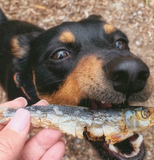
xmin=8 ymin=108 xmax=30 ymax=132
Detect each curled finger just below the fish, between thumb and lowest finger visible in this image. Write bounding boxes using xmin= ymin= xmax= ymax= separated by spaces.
xmin=20 ymin=129 xmax=62 ymax=160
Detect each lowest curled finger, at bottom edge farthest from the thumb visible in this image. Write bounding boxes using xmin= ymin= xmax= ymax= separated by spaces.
xmin=41 ymin=141 xmax=65 ymax=160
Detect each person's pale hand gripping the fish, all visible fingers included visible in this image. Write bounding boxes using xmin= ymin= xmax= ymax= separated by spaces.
xmin=0 ymin=97 xmax=66 ymax=160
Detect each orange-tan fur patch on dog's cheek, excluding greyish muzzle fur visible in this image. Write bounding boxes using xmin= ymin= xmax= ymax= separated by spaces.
xmin=35 ymin=55 xmax=102 ymax=105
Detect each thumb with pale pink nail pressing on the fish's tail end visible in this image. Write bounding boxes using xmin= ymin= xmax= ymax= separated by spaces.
xmin=0 ymin=109 xmax=30 ymax=160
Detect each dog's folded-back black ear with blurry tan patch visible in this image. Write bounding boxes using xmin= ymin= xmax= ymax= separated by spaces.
xmin=11 ymin=32 xmax=41 ymax=72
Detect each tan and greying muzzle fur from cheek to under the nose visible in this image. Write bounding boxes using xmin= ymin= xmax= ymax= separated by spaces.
xmin=34 ymin=54 xmax=151 ymax=106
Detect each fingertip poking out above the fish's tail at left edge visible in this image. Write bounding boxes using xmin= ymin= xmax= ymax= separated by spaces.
xmin=0 ymin=97 xmax=27 ymax=108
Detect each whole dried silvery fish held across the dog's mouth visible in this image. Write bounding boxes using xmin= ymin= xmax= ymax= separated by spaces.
xmin=0 ymin=105 xmax=154 ymax=145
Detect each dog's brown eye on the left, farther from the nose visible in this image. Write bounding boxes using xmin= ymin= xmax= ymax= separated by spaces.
xmin=51 ymin=50 xmax=69 ymax=60
